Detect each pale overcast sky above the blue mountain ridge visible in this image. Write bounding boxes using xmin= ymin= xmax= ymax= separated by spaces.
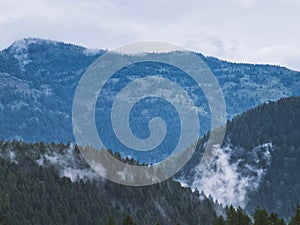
xmin=0 ymin=0 xmax=300 ymax=70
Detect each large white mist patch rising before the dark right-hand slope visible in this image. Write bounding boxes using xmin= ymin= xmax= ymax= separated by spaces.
xmin=181 ymin=143 xmax=272 ymax=208
